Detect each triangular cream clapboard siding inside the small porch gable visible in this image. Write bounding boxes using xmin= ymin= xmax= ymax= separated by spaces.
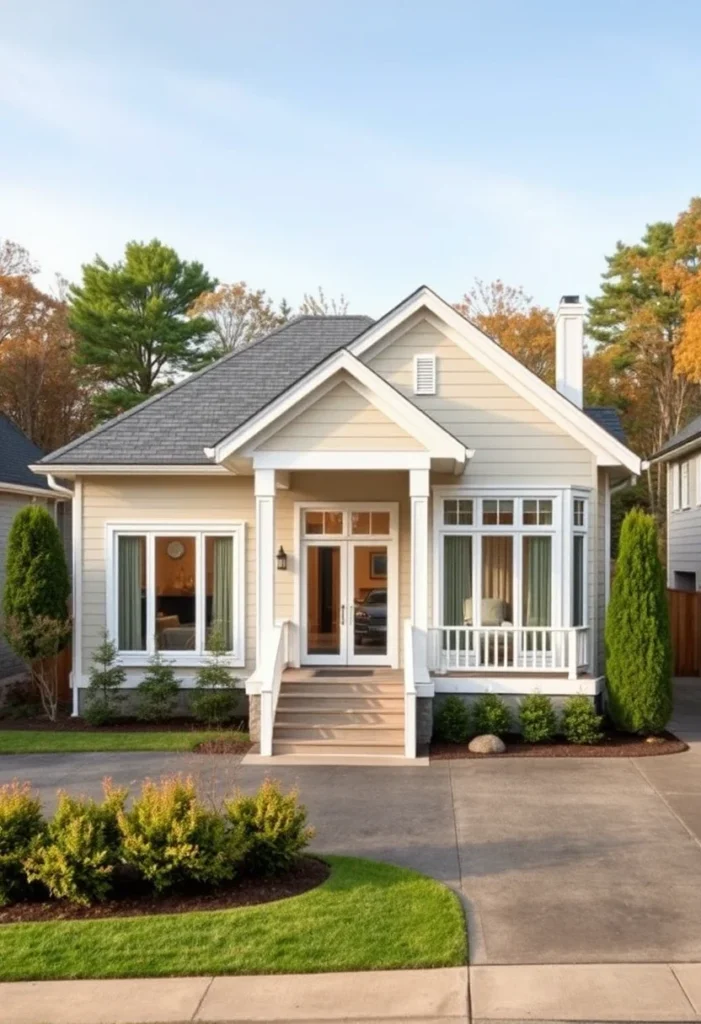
xmin=260 ymin=383 xmax=424 ymax=452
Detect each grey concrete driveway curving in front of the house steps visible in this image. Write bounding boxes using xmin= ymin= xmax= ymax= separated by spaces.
xmin=0 ymin=680 xmax=701 ymax=964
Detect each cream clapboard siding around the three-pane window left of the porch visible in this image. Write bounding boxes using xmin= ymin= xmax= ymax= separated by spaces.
xmin=83 ymin=476 xmax=256 ymax=677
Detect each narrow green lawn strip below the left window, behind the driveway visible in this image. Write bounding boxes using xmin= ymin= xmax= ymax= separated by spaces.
xmin=0 ymin=727 xmax=249 ymax=754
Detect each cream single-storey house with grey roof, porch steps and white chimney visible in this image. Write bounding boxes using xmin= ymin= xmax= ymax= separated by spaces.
xmin=35 ymin=288 xmax=641 ymax=756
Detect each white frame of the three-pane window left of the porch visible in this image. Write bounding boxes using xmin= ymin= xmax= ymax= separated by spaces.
xmin=104 ymin=519 xmax=246 ymax=668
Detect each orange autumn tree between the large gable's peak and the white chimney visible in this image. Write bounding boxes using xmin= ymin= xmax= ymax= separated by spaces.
xmin=455 ymin=278 xmax=555 ymax=384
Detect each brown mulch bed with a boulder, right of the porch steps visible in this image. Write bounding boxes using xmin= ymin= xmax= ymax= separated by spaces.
xmin=430 ymin=731 xmax=689 ymax=761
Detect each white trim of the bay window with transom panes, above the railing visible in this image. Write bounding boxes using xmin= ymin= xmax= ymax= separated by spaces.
xmin=433 ymin=485 xmax=592 ymax=629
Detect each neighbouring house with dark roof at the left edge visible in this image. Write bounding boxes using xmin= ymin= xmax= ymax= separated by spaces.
xmin=0 ymin=413 xmax=72 ymax=683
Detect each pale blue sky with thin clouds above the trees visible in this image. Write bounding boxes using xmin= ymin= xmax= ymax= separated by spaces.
xmin=0 ymin=0 xmax=701 ymax=315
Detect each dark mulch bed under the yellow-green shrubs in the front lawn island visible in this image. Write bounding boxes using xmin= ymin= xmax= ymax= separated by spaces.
xmin=0 ymin=857 xmax=331 ymax=926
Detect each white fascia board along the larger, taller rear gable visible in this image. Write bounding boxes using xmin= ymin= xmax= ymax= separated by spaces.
xmin=349 ymin=288 xmax=641 ymax=476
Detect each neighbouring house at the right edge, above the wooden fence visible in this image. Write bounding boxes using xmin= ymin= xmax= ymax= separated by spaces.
xmin=650 ymin=416 xmax=701 ymax=590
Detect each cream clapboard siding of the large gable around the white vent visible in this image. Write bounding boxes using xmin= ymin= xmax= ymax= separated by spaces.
xmin=367 ymin=321 xmax=596 ymax=487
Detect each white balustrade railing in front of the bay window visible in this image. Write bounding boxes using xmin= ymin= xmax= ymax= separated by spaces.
xmin=429 ymin=626 xmax=589 ymax=679
